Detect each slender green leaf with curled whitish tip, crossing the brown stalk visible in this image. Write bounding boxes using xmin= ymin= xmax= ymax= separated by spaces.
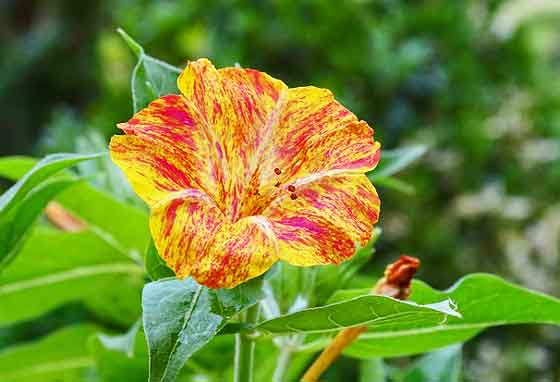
xmin=256 ymin=295 xmax=460 ymax=334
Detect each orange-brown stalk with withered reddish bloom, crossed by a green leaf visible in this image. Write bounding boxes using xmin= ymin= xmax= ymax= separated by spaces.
xmin=302 ymin=256 xmax=420 ymax=382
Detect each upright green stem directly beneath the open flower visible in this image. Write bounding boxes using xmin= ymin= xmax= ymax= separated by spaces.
xmin=233 ymin=304 xmax=259 ymax=382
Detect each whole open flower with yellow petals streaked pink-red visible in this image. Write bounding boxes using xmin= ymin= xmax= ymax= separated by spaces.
xmin=110 ymin=59 xmax=380 ymax=288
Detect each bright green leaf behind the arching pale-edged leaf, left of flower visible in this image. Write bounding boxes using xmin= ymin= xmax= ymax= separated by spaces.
xmin=0 ymin=156 xmax=150 ymax=260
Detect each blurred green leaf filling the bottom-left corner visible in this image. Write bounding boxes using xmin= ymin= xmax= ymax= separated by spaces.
xmin=0 ymin=325 xmax=97 ymax=382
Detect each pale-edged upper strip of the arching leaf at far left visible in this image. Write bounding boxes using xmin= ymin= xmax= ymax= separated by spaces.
xmin=0 ymin=154 xmax=103 ymax=216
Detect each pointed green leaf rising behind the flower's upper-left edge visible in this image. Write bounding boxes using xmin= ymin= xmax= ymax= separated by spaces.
xmin=117 ymin=28 xmax=181 ymax=112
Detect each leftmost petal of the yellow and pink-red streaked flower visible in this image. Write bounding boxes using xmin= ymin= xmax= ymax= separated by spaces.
xmin=110 ymin=95 xmax=220 ymax=206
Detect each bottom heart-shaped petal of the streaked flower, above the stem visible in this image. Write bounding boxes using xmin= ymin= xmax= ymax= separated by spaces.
xmin=150 ymin=190 xmax=277 ymax=288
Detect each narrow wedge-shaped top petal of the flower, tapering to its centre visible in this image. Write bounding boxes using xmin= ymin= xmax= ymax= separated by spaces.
xmin=177 ymin=59 xmax=287 ymax=220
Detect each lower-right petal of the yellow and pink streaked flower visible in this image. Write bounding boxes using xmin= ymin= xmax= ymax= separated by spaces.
xmin=263 ymin=174 xmax=380 ymax=266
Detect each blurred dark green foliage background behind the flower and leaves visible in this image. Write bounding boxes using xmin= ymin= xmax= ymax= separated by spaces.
xmin=0 ymin=0 xmax=560 ymax=382
